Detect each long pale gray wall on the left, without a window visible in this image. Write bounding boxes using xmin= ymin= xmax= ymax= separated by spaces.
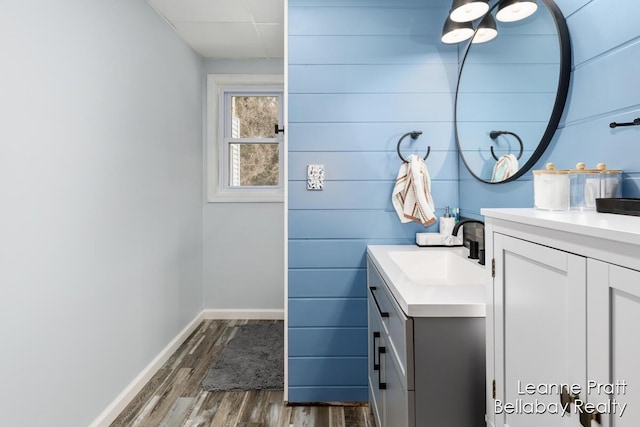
xmin=0 ymin=0 xmax=204 ymax=427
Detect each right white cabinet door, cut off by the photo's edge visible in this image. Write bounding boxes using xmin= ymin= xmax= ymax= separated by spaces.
xmin=583 ymin=259 xmax=640 ymax=427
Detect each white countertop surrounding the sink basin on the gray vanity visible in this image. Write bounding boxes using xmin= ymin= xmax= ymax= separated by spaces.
xmin=367 ymin=245 xmax=486 ymax=317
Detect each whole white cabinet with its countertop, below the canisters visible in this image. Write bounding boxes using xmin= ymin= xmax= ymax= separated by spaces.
xmin=482 ymin=209 xmax=640 ymax=427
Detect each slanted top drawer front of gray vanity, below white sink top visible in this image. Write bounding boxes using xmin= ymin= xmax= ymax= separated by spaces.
xmin=367 ymin=259 xmax=414 ymax=390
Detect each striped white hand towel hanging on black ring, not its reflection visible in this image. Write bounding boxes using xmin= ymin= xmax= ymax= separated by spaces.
xmin=391 ymin=154 xmax=436 ymax=227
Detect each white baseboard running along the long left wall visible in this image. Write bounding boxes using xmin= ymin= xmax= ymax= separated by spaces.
xmin=90 ymin=311 xmax=204 ymax=427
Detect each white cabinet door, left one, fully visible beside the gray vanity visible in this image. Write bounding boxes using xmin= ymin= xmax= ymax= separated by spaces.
xmin=493 ymin=233 xmax=586 ymax=427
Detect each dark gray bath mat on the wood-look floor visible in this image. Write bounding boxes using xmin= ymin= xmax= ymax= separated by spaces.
xmin=202 ymin=322 xmax=284 ymax=391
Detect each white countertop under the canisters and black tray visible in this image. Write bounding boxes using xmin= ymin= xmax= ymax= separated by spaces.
xmin=480 ymin=208 xmax=640 ymax=245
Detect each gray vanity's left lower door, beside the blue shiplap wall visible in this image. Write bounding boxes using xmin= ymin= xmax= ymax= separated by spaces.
xmin=367 ymin=291 xmax=385 ymax=427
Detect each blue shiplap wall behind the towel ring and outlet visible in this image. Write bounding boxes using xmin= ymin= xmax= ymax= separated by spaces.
xmin=288 ymin=0 xmax=458 ymax=402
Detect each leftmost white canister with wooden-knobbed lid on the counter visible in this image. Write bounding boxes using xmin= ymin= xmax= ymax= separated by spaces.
xmin=533 ymin=163 xmax=570 ymax=211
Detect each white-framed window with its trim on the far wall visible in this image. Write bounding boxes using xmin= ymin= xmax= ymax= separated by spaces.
xmin=207 ymin=75 xmax=284 ymax=202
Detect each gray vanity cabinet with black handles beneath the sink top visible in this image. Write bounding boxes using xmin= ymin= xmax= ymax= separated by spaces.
xmin=367 ymin=259 xmax=485 ymax=427
